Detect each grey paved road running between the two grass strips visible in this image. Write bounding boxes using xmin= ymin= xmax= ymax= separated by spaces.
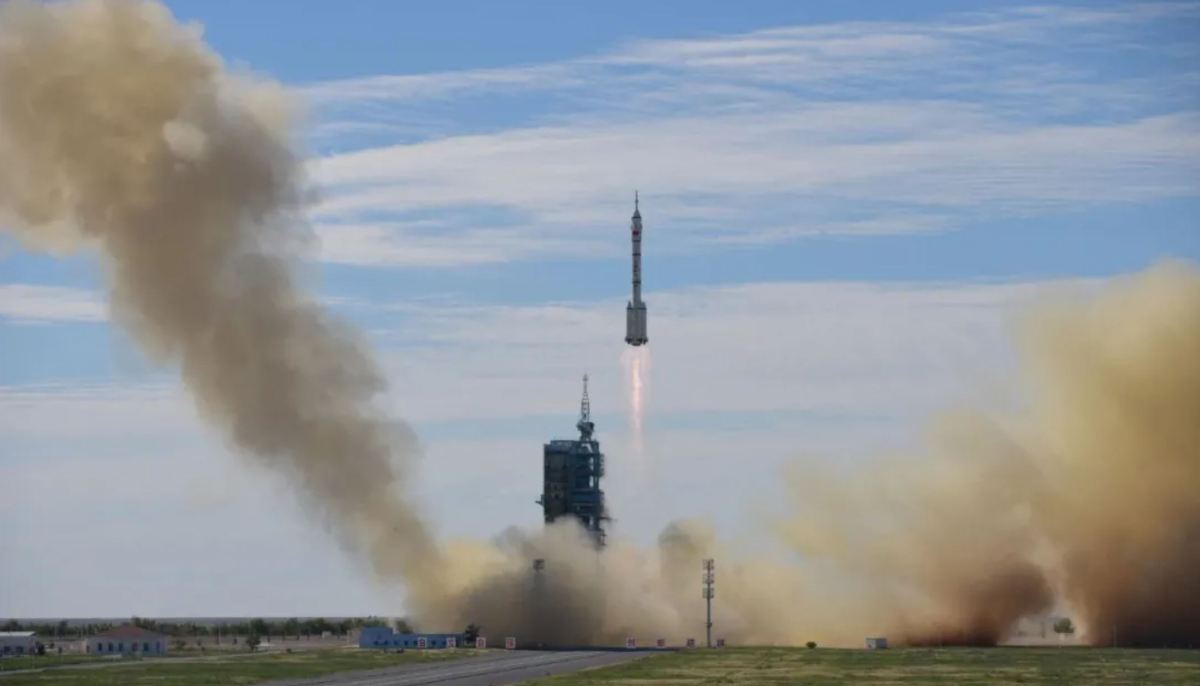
xmin=264 ymin=650 xmax=653 ymax=686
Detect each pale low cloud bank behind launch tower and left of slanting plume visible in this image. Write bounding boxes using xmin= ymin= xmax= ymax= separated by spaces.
xmin=0 ymin=273 xmax=1108 ymax=614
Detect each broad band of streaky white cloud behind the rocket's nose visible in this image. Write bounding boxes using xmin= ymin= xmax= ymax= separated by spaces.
xmin=297 ymin=2 xmax=1200 ymax=266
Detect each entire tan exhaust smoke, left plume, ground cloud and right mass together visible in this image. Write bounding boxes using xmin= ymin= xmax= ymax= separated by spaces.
xmin=0 ymin=0 xmax=1200 ymax=645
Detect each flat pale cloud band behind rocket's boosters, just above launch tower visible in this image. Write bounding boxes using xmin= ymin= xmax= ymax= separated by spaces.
xmin=362 ymin=273 xmax=1088 ymax=423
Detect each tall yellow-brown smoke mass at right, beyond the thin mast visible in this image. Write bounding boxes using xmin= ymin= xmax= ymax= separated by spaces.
xmin=785 ymin=263 xmax=1200 ymax=646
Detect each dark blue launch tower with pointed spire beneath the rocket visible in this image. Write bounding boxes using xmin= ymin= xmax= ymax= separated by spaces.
xmin=538 ymin=374 xmax=608 ymax=548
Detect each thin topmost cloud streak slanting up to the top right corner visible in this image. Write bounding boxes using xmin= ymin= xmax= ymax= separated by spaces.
xmin=300 ymin=2 xmax=1200 ymax=110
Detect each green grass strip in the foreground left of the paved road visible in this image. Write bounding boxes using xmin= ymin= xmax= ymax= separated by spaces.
xmin=0 ymin=650 xmax=478 ymax=686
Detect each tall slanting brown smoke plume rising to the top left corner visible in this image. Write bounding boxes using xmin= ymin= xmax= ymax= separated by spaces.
xmin=0 ymin=0 xmax=436 ymax=590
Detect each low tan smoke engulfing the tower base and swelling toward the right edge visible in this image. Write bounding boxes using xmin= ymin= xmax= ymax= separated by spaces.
xmin=415 ymin=263 xmax=1200 ymax=645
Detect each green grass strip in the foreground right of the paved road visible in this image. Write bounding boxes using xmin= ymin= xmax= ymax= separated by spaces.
xmin=533 ymin=648 xmax=1200 ymax=686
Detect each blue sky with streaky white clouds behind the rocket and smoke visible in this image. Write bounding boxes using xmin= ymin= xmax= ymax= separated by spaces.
xmin=0 ymin=0 xmax=1200 ymax=615
